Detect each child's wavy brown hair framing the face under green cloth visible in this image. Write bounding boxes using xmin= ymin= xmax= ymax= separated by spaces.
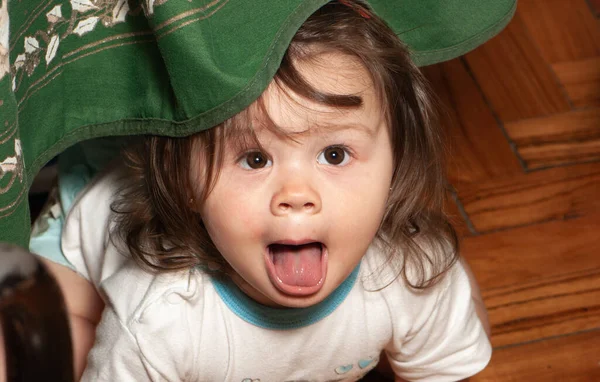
xmin=113 ymin=0 xmax=458 ymax=288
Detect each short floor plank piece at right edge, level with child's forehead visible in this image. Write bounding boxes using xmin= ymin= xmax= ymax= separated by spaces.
xmin=552 ymin=57 xmax=600 ymax=107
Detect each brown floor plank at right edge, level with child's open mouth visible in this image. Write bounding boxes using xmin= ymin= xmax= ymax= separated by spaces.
xmin=461 ymin=212 xmax=600 ymax=290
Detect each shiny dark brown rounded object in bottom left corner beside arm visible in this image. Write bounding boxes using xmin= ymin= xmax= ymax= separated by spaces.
xmin=0 ymin=243 xmax=74 ymax=382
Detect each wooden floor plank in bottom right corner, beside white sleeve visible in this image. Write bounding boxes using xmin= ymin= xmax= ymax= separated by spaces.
xmin=470 ymin=330 xmax=600 ymax=382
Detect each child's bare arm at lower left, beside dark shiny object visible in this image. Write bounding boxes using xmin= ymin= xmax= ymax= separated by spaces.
xmin=40 ymin=258 xmax=104 ymax=380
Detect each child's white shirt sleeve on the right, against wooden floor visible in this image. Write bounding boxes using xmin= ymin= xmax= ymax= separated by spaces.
xmin=386 ymin=262 xmax=492 ymax=381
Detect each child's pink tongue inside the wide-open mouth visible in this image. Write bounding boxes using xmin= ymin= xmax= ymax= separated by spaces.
xmin=271 ymin=243 xmax=323 ymax=287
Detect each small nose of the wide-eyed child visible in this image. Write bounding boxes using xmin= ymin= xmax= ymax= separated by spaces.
xmin=271 ymin=182 xmax=321 ymax=216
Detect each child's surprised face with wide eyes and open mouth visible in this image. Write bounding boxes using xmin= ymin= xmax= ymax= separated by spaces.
xmin=192 ymin=53 xmax=393 ymax=307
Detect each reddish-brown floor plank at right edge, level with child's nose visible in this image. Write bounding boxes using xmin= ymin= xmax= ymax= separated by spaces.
xmin=454 ymin=163 xmax=600 ymax=233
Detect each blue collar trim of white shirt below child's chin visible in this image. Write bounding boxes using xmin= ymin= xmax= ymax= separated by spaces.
xmin=211 ymin=263 xmax=360 ymax=330
